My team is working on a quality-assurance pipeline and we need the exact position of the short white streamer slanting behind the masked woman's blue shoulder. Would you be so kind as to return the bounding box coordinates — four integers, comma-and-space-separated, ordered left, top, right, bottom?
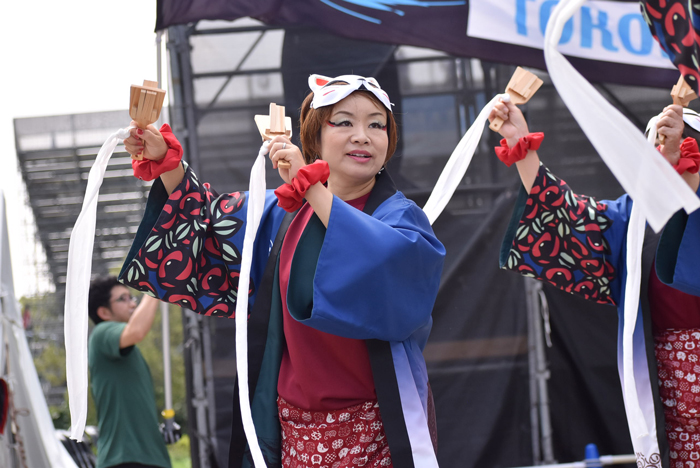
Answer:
423, 94, 510, 224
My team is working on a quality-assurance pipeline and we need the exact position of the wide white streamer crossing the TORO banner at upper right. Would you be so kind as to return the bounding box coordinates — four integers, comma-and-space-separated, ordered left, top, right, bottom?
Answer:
544, 0, 700, 232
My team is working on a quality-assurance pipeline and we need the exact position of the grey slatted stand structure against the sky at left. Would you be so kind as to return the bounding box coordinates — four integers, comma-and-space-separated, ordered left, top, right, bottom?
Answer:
15, 111, 150, 290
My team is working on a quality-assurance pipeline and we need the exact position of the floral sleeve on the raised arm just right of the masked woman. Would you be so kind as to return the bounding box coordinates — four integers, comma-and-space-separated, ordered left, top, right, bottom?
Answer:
500, 165, 631, 305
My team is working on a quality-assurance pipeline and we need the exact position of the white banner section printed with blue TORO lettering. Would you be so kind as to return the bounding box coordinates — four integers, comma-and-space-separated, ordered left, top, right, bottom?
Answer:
467, 0, 675, 69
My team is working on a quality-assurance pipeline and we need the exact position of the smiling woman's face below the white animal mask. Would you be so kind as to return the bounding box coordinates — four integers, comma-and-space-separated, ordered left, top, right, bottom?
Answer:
321, 93, 389, 186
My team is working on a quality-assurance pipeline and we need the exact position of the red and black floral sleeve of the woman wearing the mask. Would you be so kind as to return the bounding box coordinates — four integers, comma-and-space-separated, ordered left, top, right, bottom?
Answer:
119, 162, 284, 317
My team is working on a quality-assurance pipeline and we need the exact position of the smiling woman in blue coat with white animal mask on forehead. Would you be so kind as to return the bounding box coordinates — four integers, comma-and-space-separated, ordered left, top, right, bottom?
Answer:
115, 75, 445, 467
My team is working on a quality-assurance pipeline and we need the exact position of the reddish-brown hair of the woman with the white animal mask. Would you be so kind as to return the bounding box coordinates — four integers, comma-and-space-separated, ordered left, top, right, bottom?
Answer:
299, 89, 399, 164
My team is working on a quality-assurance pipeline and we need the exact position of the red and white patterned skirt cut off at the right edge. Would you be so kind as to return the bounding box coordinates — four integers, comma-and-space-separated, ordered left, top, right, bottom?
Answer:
654, 328, 700, 468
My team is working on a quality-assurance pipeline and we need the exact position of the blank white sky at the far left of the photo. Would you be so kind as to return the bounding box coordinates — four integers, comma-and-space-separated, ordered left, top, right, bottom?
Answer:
0, 0, 160, 297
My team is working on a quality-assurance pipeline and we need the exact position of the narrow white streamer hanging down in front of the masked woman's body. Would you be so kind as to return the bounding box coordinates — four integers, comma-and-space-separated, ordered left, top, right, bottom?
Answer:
236, 141, 270, 468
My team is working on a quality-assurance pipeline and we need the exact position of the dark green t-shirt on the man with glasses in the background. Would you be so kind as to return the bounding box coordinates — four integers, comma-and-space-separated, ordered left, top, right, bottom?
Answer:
88, 322, 170, 468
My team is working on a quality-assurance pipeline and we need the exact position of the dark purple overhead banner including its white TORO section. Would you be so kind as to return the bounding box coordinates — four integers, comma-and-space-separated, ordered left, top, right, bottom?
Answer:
156, 0, 678, 89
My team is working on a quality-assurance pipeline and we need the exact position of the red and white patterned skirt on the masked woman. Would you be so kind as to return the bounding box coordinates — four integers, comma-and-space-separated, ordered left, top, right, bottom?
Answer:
277, 397, 393, 468
